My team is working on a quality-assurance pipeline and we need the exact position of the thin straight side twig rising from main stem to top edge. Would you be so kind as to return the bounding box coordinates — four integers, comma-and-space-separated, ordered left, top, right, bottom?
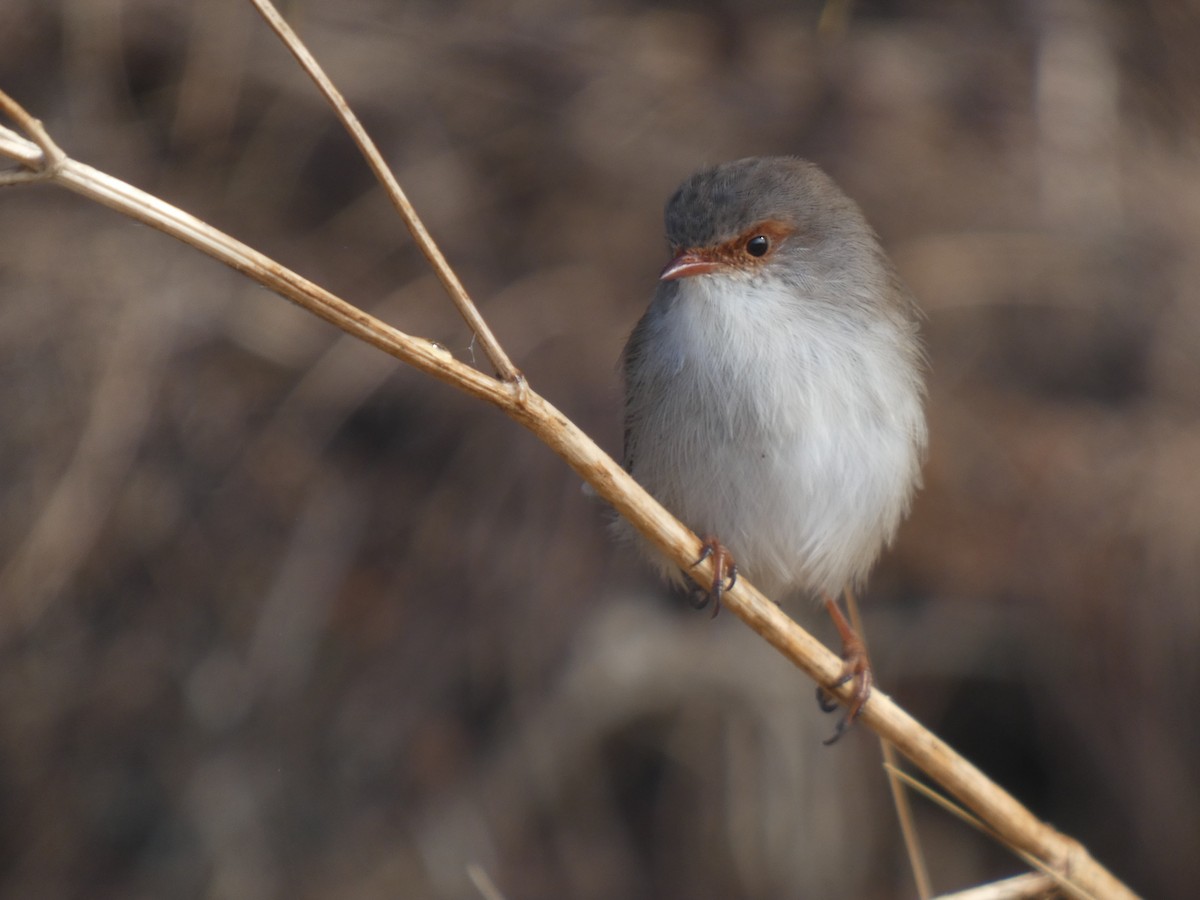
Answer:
250, 0, 524, 390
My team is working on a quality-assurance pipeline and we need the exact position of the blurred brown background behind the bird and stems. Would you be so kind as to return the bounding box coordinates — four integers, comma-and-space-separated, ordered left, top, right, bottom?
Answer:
0, 0, 1200, 900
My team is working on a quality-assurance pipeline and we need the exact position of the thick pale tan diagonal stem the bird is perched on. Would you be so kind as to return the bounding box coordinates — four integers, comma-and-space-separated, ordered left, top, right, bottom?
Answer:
0, 82, 1134, 899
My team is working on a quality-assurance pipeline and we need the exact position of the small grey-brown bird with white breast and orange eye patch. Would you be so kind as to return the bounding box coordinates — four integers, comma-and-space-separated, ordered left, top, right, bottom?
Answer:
620, 156, 928, 740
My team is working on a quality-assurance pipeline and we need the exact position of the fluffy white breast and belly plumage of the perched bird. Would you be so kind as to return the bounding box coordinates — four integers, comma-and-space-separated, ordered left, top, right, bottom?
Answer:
628, 277, 925, 599
